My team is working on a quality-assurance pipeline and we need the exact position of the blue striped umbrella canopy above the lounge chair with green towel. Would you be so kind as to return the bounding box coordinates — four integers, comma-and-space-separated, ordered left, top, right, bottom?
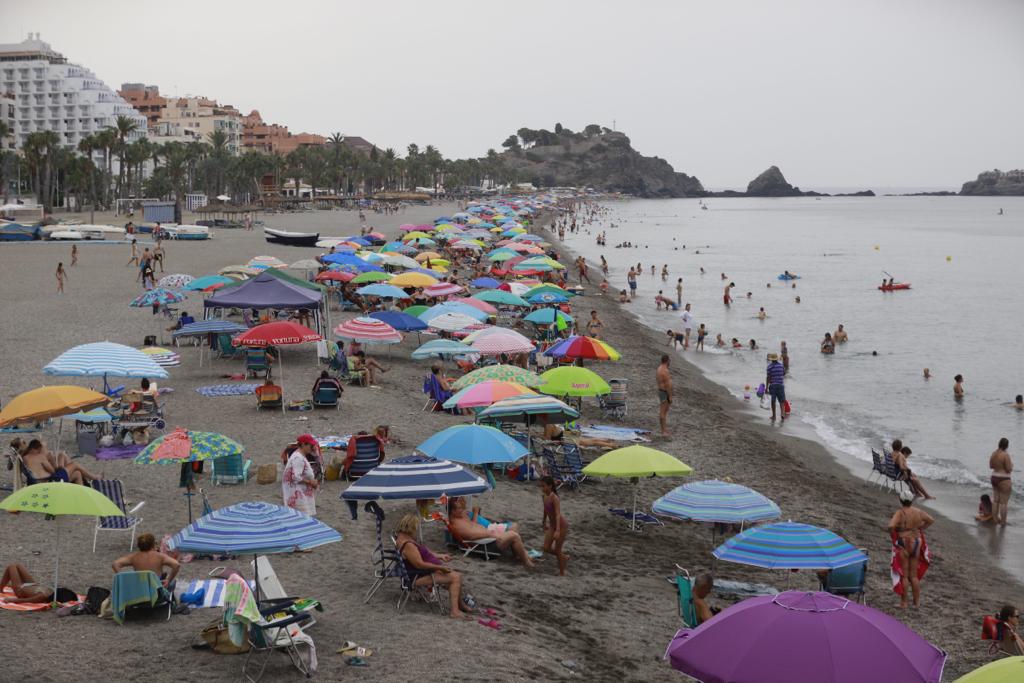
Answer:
169, 502, 341, 555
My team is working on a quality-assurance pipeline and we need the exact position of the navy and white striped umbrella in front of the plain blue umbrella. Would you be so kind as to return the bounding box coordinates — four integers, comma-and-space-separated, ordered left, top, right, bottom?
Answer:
341, 458, 489, 501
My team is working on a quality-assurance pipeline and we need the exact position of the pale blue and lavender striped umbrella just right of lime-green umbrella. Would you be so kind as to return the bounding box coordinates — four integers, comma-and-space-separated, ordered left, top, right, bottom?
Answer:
651, 479, 782, 524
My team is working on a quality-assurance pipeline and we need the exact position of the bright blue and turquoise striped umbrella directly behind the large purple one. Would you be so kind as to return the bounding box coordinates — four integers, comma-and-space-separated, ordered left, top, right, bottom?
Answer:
712, 522, 867, 569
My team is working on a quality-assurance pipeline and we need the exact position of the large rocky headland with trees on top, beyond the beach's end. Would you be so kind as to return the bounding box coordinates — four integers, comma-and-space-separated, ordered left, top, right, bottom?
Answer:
498, 124, 707, 198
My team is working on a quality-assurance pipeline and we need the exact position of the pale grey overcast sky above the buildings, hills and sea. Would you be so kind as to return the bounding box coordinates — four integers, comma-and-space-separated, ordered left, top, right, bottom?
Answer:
8, 0, 1024, 188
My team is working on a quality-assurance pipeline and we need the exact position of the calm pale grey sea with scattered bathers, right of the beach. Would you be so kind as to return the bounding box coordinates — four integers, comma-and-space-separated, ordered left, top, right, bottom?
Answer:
566, 197, 1024, 574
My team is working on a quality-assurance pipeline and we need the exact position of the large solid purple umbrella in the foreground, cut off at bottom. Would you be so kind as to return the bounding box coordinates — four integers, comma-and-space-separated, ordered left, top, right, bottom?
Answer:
666, 591, 946, 683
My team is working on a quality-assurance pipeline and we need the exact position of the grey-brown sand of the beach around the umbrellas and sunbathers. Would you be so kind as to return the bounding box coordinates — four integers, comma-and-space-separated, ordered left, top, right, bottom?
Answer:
0, 204, 1024, 681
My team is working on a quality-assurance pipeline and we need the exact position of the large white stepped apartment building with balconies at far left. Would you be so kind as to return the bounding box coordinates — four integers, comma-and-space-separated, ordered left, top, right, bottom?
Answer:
0, 33, 146, 147
